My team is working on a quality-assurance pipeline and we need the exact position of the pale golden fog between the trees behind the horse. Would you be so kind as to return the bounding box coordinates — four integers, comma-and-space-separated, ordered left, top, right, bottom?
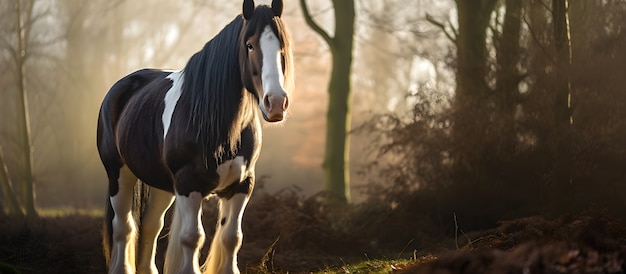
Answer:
0, 0, 446, 207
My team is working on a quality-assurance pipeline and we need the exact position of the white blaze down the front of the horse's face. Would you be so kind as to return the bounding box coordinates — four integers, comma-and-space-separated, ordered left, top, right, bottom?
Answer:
259, 26, 285, 105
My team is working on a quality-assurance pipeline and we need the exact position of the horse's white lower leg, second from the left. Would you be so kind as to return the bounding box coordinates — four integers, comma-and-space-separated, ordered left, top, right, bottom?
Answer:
137, 187, 174, 274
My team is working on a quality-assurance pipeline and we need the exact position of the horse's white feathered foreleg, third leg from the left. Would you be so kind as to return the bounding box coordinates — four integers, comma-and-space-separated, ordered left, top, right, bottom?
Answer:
164, 192, 204, 274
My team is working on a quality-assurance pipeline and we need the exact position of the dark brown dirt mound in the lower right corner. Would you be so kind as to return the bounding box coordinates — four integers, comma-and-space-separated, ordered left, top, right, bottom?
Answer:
396, 212, 626, 274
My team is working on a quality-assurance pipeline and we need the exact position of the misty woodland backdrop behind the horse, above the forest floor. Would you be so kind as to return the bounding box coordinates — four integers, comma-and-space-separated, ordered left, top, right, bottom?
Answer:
0, 0, 626, 228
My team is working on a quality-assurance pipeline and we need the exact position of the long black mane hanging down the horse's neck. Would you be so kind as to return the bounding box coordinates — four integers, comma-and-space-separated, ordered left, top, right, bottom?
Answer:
182, 16, 250, 161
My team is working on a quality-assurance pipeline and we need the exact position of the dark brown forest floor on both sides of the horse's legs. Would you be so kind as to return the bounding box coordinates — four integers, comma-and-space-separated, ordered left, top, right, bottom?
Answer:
0, 209, 626, 274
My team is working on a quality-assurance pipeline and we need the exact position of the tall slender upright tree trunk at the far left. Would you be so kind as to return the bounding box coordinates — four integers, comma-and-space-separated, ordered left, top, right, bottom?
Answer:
15, 0, 37, 217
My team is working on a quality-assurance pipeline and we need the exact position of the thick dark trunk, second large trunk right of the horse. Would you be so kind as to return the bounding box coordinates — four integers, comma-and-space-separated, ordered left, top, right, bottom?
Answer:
452, 0, 497, 163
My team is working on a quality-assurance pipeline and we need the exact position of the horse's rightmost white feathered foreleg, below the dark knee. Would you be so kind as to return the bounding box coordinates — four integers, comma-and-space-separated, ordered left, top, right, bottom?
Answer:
207, 193, 249, 274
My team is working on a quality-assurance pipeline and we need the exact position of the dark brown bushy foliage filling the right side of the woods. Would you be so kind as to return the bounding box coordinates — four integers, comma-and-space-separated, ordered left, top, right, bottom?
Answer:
354, 1, 626, 232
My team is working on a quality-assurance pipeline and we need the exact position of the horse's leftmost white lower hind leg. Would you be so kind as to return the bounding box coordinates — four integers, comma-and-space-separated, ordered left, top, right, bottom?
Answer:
109, 166, 137, 273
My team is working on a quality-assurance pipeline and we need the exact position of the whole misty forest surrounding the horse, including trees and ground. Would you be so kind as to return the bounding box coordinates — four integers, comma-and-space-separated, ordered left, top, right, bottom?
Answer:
0, 0, 626, 273
